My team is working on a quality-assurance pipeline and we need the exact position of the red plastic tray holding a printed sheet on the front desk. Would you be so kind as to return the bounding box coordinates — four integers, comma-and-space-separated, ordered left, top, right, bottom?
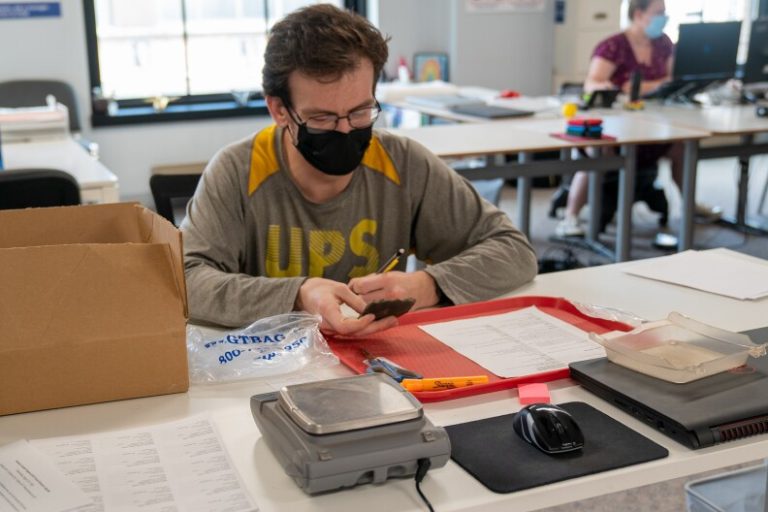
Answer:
328, 296, 632, 402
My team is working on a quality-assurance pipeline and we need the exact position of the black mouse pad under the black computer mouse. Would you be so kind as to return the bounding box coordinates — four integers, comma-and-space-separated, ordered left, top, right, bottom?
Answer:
445, 402, 669, 493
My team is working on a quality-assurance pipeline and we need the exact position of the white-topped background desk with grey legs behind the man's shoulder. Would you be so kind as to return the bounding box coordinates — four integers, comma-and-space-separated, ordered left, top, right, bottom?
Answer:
391, 114, 709, 261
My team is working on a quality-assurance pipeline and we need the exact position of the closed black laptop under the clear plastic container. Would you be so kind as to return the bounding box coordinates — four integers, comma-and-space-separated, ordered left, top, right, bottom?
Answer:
570, 328, 768, 449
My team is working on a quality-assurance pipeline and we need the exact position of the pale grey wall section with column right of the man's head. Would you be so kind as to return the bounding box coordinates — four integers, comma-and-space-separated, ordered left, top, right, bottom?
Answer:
378, 0, 554, 94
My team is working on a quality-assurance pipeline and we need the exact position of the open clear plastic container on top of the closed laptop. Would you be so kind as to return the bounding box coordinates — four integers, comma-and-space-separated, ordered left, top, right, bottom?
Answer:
589, 313, 767, 384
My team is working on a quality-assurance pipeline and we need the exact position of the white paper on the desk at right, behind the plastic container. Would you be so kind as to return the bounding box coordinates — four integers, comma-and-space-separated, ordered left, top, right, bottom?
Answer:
624, 249, 768, 300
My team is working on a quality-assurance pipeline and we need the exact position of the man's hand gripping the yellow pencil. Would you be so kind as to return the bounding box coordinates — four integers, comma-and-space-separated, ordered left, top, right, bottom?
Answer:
349, 270, 439, 309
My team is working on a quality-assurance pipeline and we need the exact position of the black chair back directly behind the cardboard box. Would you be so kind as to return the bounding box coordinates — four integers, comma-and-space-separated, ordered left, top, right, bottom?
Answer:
0, 169, 80, 210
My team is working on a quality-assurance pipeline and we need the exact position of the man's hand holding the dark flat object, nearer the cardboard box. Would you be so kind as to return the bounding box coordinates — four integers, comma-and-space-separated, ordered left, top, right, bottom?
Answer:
296, 277, 397, 336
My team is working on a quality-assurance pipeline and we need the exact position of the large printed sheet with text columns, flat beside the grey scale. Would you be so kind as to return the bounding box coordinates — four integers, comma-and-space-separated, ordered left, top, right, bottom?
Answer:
30, 415, 258, 512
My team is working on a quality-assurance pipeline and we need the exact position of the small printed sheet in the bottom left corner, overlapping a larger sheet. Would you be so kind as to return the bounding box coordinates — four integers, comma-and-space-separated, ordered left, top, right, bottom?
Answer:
0, 440, 91, 512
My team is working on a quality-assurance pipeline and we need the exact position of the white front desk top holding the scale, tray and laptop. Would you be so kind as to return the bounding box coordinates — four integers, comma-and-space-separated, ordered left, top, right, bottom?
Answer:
0, 250, 768, 512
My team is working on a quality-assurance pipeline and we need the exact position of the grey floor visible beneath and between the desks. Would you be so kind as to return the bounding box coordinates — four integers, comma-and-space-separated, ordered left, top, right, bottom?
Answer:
492, 156, 768, 512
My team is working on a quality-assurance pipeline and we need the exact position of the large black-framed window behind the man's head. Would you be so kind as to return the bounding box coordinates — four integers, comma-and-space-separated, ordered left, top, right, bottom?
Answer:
84, 0, 365, 126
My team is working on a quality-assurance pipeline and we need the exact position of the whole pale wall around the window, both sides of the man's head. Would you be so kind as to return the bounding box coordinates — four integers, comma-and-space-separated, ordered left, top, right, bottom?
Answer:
0, 0, 554, 206
